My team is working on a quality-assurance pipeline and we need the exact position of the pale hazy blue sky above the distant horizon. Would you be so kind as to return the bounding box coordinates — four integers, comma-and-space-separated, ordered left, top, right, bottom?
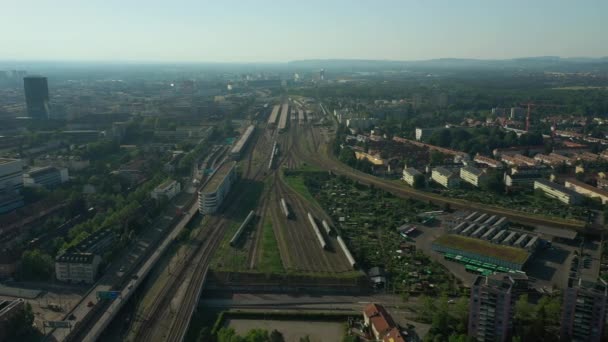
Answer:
0, 0, 608, 62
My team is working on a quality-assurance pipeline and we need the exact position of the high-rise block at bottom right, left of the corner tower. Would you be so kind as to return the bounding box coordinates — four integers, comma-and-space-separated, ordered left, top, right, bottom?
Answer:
469, 273, 527, 342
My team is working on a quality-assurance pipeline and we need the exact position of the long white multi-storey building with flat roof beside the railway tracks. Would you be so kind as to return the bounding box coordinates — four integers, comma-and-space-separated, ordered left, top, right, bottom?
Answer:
199, 162, 236, 215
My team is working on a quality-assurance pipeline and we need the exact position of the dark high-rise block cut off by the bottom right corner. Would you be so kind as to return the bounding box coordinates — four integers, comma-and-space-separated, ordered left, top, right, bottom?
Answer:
560, 278, 608, 342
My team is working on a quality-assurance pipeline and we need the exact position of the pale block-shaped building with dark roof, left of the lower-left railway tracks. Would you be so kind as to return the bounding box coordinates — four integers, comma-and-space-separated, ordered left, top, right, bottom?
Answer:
55, 251, 101, 284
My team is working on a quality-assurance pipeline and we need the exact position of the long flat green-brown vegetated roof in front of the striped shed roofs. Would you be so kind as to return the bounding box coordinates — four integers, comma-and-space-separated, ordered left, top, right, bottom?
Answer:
434, 234, 530, 264
